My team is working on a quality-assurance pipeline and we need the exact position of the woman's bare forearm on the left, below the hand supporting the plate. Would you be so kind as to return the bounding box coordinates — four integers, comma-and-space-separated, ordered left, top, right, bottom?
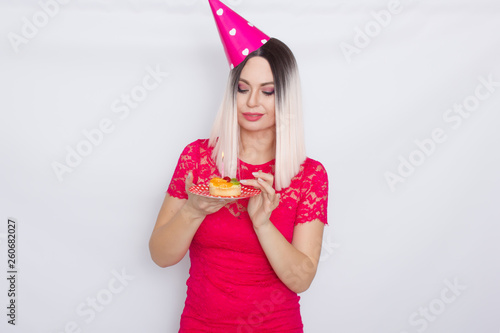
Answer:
149, 204, 204, 267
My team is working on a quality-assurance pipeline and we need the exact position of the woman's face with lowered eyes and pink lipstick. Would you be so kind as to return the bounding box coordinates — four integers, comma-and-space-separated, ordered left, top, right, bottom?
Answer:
236, 57, 275, 132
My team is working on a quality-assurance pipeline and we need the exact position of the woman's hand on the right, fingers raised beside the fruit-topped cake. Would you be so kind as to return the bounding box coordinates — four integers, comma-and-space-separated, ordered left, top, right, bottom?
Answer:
240, 171, 280, 228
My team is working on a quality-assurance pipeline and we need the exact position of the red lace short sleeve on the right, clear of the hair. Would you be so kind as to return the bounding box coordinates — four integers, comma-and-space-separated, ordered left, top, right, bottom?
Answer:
295, 160, 328, 224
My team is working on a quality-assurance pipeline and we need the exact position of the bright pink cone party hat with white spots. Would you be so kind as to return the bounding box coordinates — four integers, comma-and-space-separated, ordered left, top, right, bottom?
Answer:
208, 0, 269, 69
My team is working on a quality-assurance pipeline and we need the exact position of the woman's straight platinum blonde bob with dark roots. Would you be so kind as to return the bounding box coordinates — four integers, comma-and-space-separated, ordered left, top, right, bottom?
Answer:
209, 38, 306, 191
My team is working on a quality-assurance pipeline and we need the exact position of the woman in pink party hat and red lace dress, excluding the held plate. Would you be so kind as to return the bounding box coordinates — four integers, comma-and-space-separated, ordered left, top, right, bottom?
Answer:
149, 0, 328, 333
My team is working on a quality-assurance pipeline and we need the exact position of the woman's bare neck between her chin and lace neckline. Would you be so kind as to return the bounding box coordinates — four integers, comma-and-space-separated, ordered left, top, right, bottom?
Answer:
238, 128, 276, 164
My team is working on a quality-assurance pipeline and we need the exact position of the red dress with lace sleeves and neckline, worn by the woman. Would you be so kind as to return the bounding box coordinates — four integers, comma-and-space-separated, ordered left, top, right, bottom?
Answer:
167, 140, 328, 333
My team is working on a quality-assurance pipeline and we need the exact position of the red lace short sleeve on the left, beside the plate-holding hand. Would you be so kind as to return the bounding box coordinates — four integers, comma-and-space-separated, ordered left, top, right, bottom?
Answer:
167, 141, 200, 199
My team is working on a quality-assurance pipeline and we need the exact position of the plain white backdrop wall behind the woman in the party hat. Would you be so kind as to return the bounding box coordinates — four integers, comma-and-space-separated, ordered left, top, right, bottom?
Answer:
0, 0, 500, 333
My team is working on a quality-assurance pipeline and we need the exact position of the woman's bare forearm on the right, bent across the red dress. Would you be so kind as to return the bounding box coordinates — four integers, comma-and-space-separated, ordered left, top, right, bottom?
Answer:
254, 221, 317, 293
